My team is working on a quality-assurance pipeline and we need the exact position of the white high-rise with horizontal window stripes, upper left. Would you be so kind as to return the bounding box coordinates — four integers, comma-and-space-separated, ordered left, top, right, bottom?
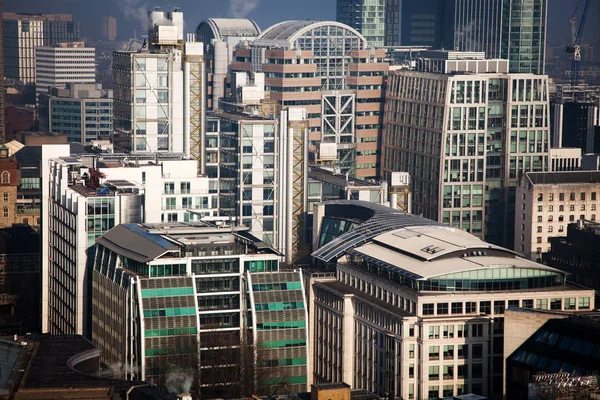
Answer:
35, 42, 96, 104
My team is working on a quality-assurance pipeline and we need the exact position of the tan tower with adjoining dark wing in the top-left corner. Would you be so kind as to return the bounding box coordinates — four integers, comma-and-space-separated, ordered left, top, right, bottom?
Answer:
3, 13, 79, 85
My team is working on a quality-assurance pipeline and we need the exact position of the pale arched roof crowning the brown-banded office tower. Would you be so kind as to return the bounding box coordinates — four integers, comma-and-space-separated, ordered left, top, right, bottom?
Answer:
254, 21, 367, 48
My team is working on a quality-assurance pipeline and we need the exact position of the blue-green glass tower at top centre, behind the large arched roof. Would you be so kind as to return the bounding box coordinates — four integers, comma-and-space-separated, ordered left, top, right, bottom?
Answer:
336, 0, 401, 47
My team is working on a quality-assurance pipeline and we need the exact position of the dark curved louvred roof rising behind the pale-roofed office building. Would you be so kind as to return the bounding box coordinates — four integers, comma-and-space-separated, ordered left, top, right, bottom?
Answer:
312, 200, 440, 263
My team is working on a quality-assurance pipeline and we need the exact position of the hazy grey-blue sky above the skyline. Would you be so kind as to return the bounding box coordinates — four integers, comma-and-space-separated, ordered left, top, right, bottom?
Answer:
4, 0, 600, 47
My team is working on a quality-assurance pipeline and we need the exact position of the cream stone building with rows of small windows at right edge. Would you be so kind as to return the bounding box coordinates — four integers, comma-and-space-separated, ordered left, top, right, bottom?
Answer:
514, 171, 600, 261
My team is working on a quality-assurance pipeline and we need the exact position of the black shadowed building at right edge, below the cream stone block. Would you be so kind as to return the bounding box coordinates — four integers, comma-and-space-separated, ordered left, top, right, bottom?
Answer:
542, 220, 600, 298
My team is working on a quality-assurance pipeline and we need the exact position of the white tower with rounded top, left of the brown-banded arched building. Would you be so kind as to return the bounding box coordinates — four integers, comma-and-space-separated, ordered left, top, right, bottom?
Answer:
196, 18, 260, 110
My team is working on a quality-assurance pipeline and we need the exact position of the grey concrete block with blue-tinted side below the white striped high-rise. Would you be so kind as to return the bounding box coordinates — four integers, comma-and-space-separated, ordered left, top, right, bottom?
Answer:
39, 83, 113, 145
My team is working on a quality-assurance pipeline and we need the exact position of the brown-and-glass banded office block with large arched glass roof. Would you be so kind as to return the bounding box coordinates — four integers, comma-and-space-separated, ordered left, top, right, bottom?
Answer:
232, 21, 389, 179
